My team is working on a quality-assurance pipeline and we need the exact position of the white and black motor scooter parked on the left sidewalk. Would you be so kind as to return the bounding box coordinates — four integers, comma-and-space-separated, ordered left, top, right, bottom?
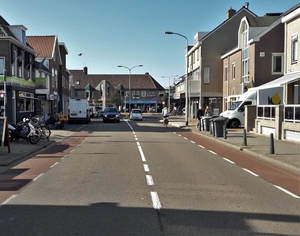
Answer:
8, 118, 40, 144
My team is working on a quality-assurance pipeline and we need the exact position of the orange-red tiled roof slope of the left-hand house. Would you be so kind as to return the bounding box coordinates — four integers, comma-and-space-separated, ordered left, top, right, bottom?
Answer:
26, 35, 57, 58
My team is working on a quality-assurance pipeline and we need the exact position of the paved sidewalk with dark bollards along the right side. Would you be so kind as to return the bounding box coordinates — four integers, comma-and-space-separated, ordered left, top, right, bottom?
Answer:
169, 116, 300, 174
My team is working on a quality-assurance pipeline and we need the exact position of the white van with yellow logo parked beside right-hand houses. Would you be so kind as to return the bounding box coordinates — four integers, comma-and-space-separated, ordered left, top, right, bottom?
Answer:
220, 86, 283, 128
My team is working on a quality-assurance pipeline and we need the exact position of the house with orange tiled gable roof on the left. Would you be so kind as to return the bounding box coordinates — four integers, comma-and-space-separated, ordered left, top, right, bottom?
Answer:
27, 35, 69, 114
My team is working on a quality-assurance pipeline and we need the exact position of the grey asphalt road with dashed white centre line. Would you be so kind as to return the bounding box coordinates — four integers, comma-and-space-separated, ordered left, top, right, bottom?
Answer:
0, 116, 300, 235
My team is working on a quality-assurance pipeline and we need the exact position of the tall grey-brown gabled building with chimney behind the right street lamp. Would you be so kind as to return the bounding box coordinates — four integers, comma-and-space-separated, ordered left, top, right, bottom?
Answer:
188, 5, 257, 117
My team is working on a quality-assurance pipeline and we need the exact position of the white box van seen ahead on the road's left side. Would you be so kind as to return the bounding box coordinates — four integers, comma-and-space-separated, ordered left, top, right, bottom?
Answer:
68, 98, 91, 124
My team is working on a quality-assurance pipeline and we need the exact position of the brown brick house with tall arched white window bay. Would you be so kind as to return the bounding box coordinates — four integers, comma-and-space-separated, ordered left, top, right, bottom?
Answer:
221, 14, 284, 110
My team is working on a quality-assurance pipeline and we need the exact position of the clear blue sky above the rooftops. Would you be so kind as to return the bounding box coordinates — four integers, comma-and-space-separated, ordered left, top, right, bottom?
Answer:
0, 0, 299, 86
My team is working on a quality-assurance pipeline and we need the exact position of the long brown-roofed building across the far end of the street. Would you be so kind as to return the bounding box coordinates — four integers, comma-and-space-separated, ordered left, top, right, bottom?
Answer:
69, 67, 165, 111
